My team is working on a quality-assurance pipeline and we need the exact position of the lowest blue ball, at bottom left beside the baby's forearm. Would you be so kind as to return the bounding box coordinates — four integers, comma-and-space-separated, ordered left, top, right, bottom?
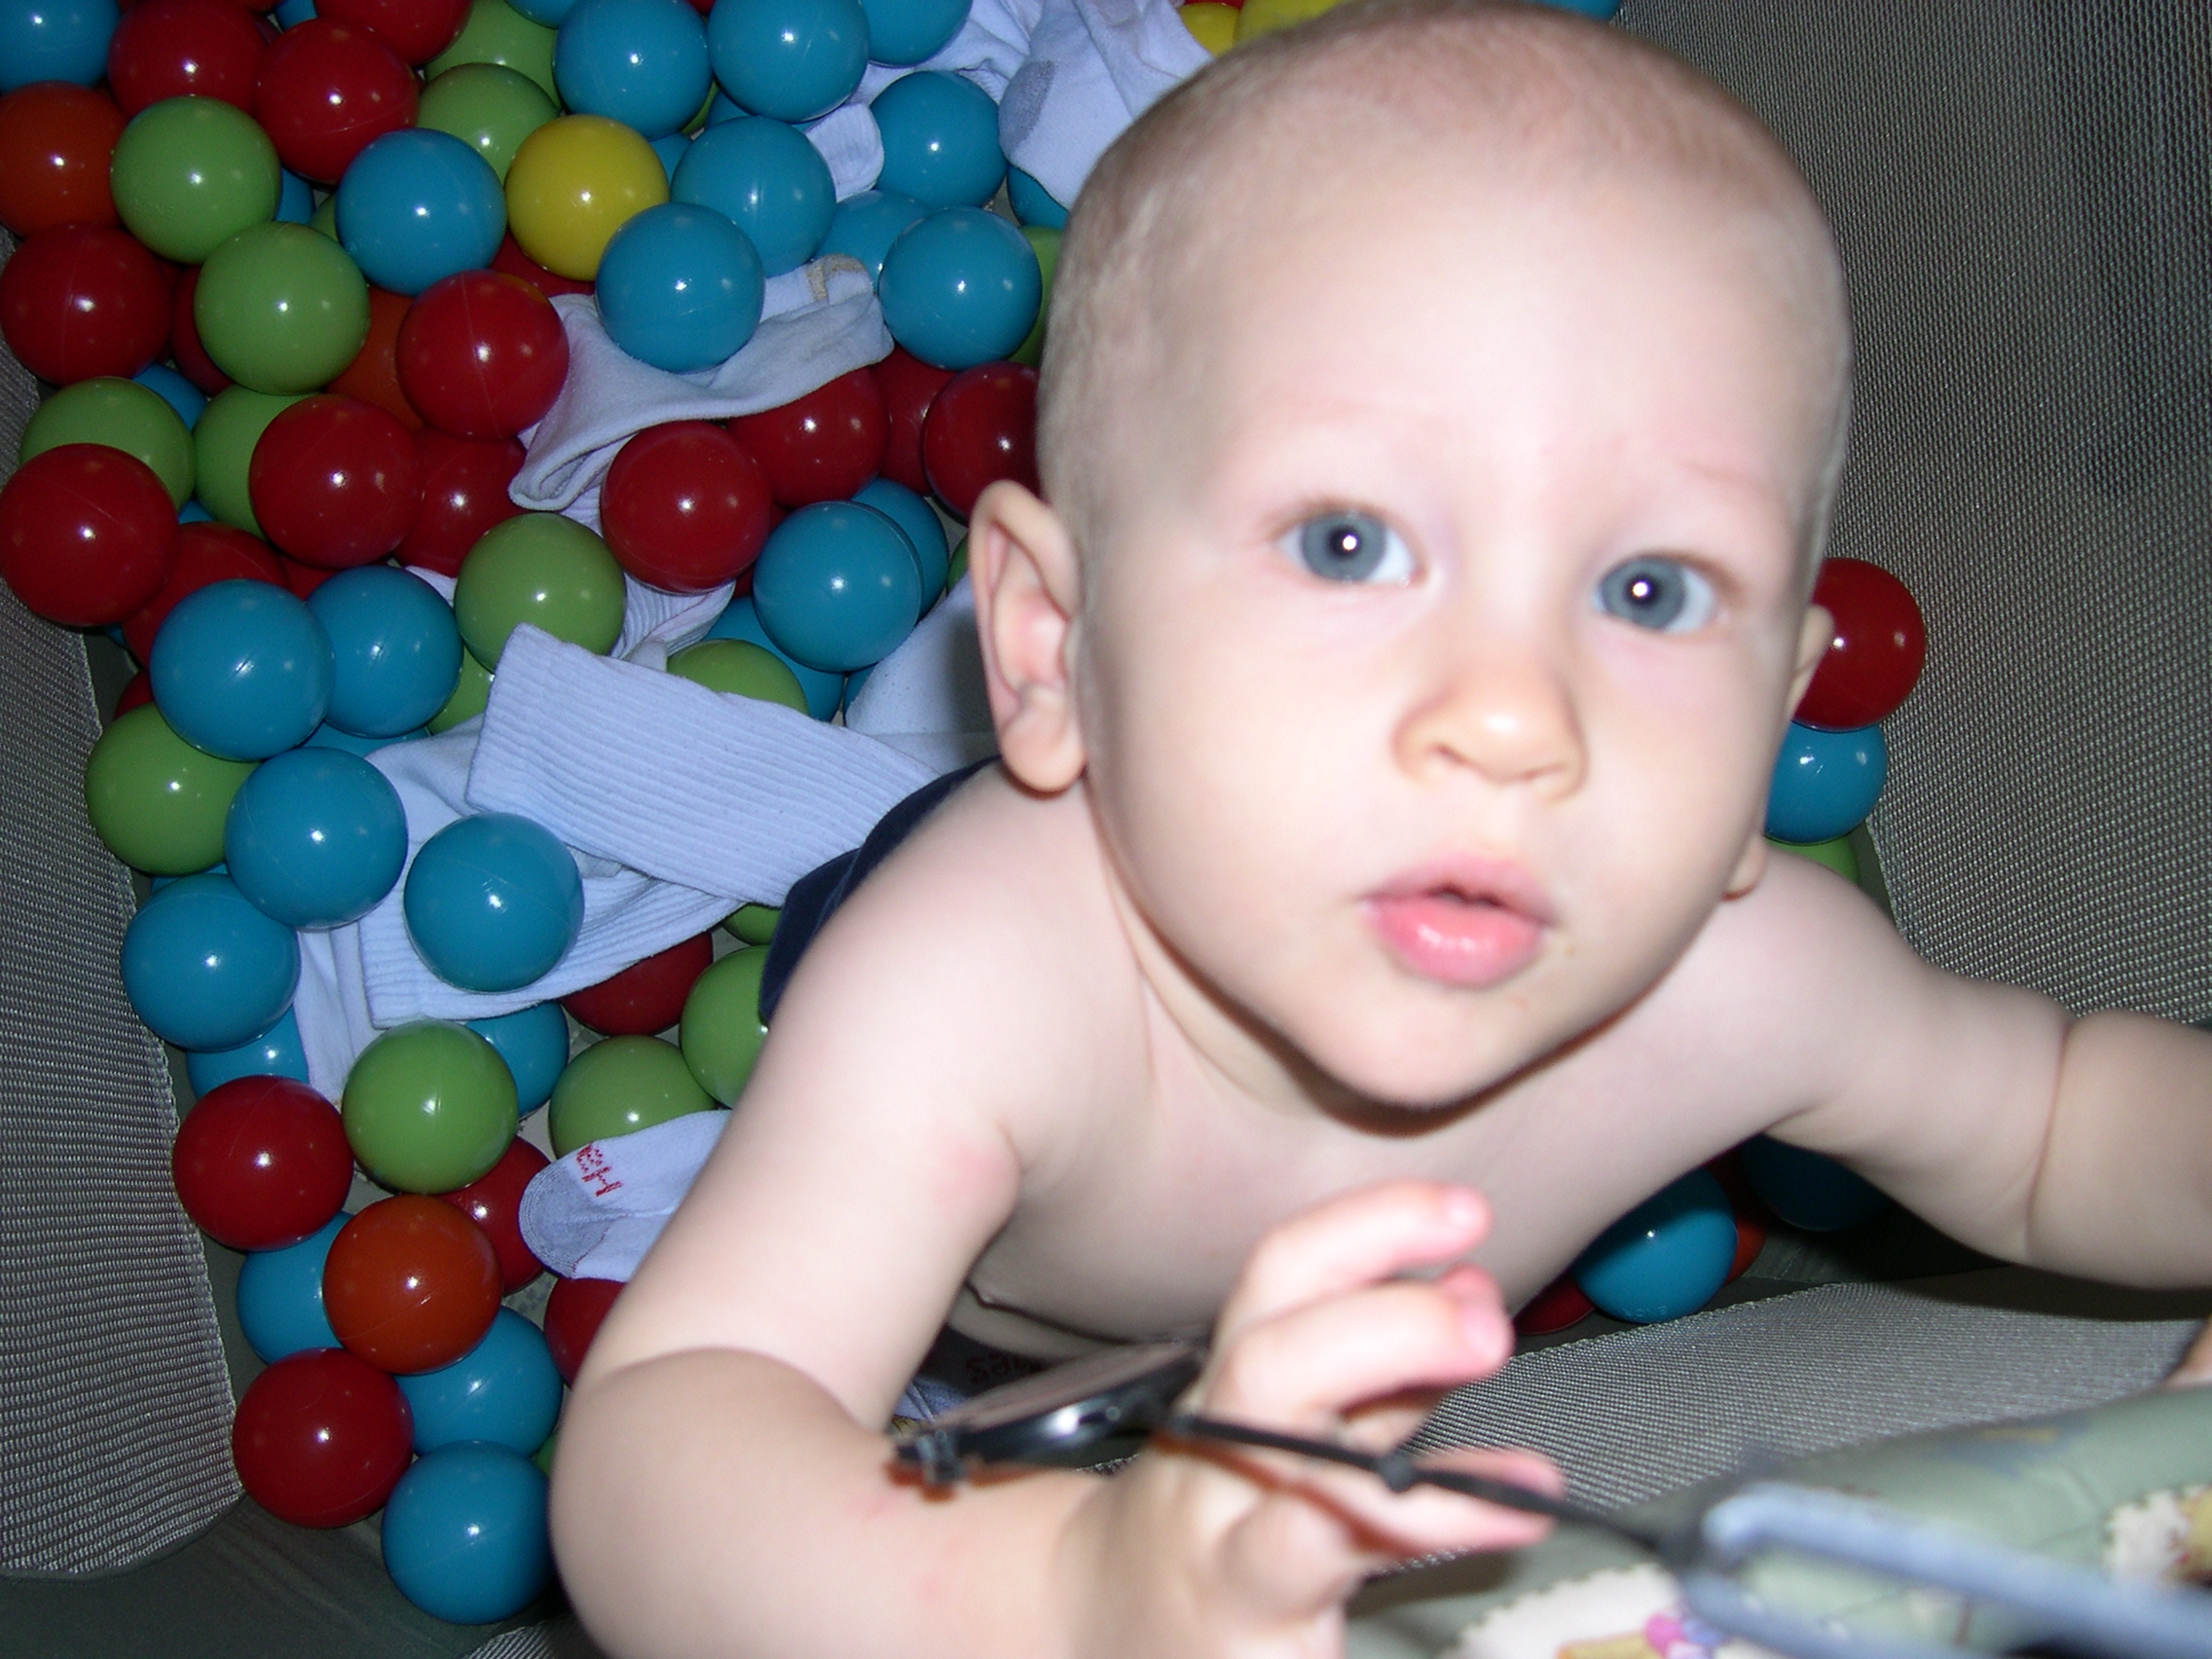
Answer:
383, 1442, 553, 1624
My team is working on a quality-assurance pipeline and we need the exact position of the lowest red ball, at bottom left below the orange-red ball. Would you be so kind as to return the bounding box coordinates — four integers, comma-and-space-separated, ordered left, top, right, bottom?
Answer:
230, 1347, 414, 1527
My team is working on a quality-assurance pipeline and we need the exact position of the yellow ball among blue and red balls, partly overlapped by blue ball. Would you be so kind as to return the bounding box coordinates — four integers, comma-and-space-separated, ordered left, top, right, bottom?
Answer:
506, 115, 668, 283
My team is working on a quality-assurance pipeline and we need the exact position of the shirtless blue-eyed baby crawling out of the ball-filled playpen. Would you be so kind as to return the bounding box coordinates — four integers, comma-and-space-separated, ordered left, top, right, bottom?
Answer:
539, 0, 2212, 1659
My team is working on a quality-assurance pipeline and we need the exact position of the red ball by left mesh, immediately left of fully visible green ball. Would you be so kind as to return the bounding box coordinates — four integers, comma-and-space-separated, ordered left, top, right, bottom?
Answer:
168, 1077, 354, 1250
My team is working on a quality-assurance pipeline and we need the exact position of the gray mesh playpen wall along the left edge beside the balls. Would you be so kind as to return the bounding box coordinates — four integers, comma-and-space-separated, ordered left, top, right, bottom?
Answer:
0, 239, 239, 1572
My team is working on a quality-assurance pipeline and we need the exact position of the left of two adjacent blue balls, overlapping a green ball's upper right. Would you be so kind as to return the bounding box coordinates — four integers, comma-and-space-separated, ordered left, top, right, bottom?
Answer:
148, 582, 332, 765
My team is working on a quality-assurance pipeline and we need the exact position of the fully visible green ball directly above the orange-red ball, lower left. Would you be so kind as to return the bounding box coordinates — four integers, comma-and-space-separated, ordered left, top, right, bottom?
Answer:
339, 1019, 515, 1193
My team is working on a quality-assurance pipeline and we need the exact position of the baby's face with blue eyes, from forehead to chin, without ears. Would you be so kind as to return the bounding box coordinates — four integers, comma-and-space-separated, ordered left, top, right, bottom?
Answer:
1075, 149, 1833, 1104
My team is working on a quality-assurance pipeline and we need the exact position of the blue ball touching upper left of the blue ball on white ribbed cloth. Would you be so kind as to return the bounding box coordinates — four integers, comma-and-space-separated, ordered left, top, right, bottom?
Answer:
223, 748, 407, 927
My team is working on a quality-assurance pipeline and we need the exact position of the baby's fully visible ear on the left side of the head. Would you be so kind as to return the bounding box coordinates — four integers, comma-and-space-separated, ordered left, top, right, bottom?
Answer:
969, 482, 1084, 794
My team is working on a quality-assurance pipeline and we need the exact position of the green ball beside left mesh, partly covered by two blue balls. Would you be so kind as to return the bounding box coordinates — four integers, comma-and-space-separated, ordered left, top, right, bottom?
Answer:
84, 703, 254, 876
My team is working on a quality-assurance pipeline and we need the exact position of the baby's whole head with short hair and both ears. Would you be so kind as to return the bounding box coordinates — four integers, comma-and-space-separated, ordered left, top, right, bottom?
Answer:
971, 0, 1847, 1119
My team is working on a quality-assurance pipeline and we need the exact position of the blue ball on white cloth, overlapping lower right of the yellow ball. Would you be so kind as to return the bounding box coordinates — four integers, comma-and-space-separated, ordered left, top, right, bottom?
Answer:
597, 202, 767, 374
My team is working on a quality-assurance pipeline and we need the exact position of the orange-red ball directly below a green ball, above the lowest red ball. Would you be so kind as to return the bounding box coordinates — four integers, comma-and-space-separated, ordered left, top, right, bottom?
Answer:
323, 1193, 499, 1372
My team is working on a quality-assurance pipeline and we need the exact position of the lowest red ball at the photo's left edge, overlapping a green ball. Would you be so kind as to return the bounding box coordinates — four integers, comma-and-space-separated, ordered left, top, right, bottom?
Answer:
0, 449, 177, 628
